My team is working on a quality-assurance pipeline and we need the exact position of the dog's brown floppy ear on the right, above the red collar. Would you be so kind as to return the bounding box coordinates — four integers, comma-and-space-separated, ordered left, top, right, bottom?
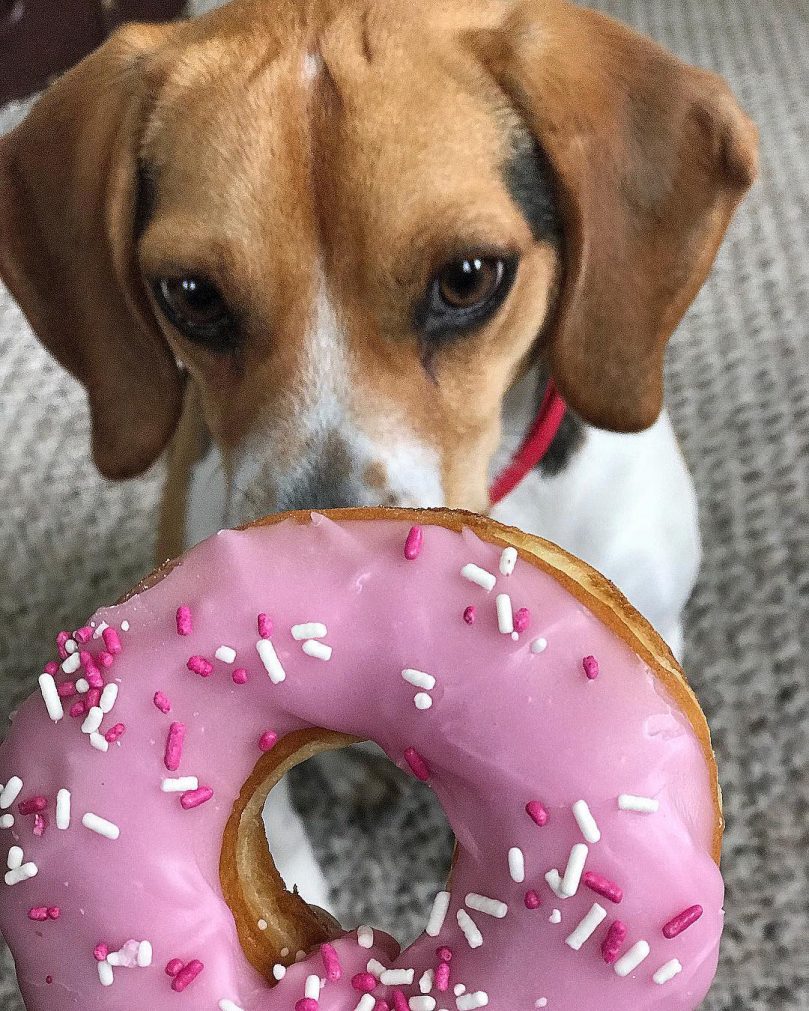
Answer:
475, 0, 757, 431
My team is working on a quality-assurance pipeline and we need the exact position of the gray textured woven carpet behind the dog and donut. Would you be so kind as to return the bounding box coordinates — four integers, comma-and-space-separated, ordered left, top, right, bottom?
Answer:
0, 0, 809, 1011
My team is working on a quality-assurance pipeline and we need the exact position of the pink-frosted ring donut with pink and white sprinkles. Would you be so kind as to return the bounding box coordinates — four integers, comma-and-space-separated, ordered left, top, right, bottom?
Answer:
0, 510, 723, 1011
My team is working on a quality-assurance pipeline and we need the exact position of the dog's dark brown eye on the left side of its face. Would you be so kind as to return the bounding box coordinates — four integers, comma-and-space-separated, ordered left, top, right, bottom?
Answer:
153, 277, 236, 351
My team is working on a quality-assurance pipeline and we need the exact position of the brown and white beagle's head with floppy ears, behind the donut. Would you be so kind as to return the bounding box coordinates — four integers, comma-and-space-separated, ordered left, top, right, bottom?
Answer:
0, 0, 755, 510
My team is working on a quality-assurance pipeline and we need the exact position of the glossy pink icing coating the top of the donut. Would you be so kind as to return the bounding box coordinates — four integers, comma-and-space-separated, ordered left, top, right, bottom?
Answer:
0, 516, 723, 1011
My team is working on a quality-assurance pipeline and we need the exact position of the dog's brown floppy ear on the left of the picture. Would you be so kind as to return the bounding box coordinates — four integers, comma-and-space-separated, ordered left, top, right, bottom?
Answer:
0, 26, 182, 477
